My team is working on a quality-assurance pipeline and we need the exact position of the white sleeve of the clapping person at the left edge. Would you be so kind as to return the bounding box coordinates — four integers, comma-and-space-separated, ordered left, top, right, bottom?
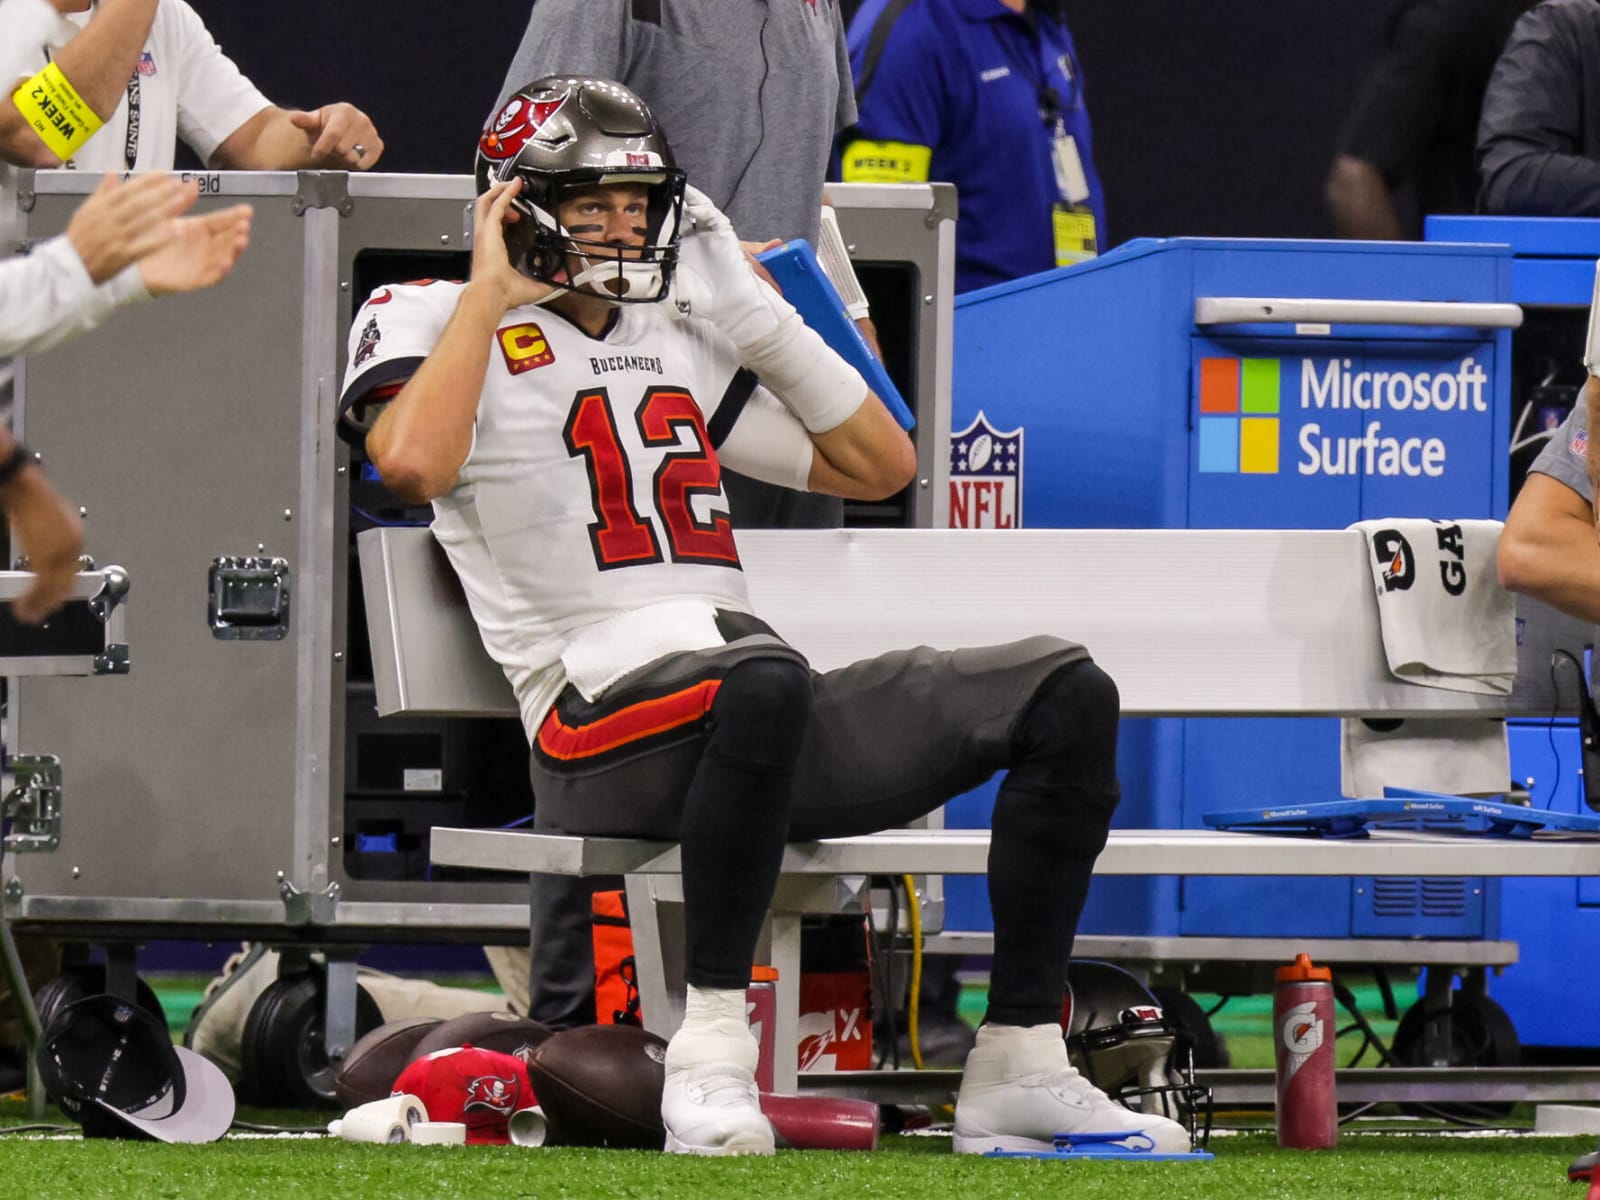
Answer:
0, 237, 150, 358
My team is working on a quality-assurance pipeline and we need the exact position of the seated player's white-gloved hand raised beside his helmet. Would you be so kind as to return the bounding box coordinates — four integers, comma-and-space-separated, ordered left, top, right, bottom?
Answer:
672, 187, 794, 347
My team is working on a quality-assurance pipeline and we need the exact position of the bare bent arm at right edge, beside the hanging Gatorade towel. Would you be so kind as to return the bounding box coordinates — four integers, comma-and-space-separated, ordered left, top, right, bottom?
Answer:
1498, 472, 1600, 624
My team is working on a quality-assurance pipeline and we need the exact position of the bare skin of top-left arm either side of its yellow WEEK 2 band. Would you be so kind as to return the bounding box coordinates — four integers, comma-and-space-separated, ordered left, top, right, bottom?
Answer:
0, 0, 158, 166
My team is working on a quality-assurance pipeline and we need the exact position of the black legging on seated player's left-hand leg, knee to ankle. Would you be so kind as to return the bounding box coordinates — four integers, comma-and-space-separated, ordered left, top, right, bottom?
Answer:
680, 658, 811, 989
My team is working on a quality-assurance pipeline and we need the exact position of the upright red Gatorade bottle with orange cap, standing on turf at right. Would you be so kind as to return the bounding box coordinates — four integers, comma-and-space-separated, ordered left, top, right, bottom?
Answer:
1272, 954, 1339, 1150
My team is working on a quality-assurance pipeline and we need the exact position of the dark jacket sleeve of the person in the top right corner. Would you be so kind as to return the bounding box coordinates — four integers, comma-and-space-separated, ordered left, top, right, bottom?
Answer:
1478, 6, 1600, 216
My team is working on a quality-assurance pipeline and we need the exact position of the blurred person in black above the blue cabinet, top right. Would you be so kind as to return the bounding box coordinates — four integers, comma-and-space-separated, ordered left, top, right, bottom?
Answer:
1323, 0, 1533, 242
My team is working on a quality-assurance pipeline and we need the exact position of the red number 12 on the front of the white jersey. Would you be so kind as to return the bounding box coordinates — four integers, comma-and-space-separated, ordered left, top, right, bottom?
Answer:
562, 387, 739, 571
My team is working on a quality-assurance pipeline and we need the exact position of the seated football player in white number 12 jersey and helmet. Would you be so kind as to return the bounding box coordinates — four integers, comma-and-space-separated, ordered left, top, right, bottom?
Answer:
341, 77, 1189, 1154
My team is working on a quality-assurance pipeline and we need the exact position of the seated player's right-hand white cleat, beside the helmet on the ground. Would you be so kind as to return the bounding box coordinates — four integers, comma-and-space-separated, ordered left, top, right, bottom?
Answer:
954, 1026, 1192, 1154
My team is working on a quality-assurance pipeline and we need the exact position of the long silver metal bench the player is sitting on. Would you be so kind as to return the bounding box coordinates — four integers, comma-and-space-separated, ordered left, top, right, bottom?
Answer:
358, 528, 1600, 1090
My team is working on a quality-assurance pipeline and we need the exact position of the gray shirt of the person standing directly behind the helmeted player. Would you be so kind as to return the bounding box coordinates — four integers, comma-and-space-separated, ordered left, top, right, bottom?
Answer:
494, 0, 856, 245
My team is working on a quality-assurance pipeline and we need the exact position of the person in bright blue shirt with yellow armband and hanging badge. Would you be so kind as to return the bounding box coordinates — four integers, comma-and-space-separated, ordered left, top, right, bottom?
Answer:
838, 0, 1106, 293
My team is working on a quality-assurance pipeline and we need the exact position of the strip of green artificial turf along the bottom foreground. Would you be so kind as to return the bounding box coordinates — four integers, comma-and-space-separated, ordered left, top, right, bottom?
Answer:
0, 1126, 1594, 1200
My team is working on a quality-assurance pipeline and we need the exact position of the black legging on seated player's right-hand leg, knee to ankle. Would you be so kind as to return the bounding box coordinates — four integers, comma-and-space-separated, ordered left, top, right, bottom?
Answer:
987, 661, 1120, 1026
